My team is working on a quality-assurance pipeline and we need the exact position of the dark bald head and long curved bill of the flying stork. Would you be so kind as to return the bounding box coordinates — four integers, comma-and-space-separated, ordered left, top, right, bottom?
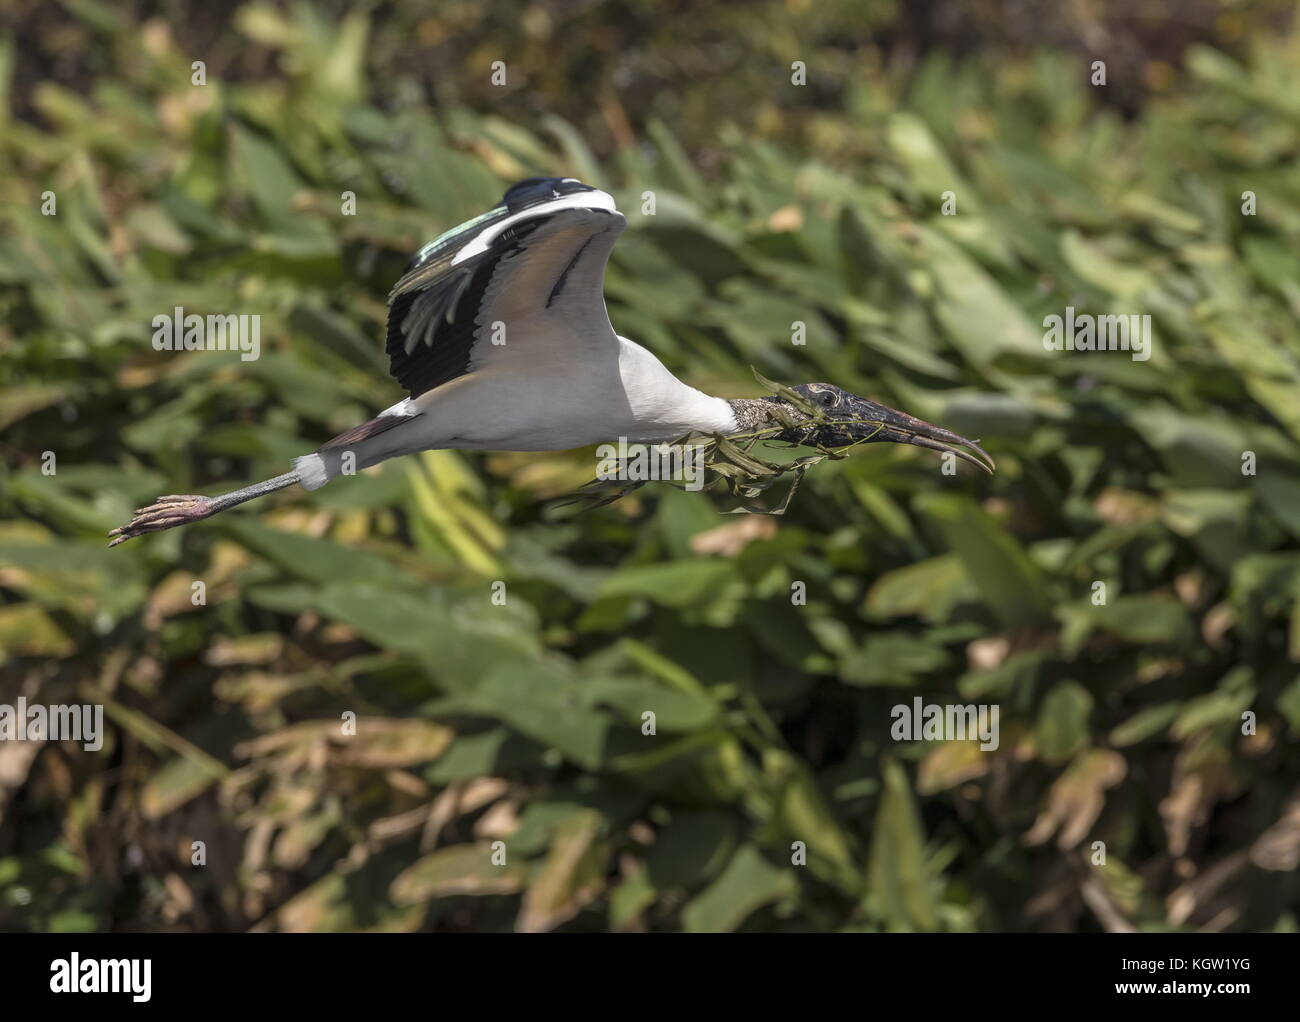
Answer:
768, 384, 995, 475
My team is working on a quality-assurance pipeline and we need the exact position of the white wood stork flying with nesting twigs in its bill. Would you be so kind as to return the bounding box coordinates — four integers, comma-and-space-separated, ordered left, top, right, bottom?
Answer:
109, 177, 993, 546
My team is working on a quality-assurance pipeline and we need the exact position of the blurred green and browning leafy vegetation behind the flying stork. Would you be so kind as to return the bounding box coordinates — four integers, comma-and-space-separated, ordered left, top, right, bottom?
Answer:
0, 0, 1300, 931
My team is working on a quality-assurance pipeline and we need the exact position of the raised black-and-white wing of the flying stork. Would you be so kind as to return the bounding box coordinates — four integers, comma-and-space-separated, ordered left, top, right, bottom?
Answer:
387, 178, 627, 397
